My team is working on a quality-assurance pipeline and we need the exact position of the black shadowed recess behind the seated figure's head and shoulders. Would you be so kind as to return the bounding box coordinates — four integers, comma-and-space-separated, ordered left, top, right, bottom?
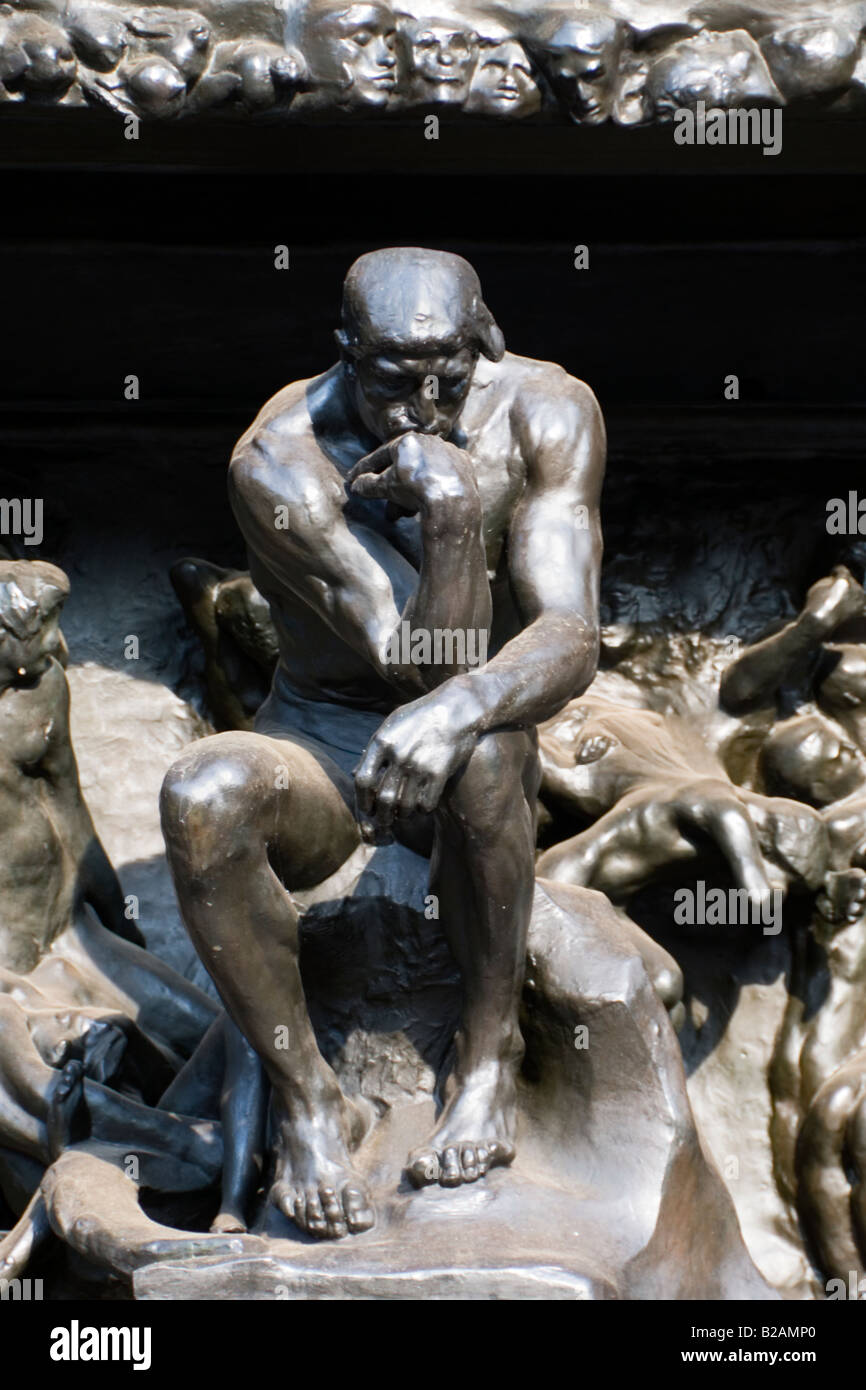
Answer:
0, 161, 866, 597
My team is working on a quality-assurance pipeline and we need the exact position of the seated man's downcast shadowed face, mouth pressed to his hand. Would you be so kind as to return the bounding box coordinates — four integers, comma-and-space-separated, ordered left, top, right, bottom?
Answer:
350, 345, 478, 439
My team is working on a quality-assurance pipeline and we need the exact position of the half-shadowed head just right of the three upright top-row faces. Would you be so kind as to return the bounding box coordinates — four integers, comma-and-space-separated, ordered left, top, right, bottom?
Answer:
544, 15, 619, 122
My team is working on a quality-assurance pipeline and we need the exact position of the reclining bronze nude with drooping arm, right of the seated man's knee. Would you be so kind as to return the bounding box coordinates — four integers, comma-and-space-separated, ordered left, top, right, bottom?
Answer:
538, 696, 827, 917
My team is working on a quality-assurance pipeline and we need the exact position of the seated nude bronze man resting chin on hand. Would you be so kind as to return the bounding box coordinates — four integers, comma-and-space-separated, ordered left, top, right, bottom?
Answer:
163, 249, 605, 1237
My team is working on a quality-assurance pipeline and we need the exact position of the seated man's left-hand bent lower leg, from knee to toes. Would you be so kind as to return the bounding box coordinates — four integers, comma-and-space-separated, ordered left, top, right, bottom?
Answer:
163, 734, 373, 1236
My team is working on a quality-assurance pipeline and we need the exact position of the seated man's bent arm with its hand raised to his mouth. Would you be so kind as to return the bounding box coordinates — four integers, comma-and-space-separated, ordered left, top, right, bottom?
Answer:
229, 430, 489, 699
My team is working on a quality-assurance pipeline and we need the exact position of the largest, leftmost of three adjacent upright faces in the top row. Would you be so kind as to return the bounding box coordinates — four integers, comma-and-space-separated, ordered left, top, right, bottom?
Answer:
310, 4, 396, 106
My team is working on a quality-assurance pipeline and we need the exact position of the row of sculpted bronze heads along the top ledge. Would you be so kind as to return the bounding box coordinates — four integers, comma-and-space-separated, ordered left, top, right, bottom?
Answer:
0, 0, 866, 125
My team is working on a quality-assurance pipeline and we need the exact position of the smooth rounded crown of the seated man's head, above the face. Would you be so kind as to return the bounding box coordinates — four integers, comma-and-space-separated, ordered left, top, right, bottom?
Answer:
339, 246, 505, 361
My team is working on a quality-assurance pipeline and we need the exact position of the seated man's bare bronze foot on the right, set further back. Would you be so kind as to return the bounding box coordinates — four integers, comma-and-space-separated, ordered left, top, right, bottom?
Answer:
406, 1063, 517, 1187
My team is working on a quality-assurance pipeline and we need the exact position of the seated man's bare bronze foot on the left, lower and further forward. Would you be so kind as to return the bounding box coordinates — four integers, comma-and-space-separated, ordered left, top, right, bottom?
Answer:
270, 1098, 375, 1240
